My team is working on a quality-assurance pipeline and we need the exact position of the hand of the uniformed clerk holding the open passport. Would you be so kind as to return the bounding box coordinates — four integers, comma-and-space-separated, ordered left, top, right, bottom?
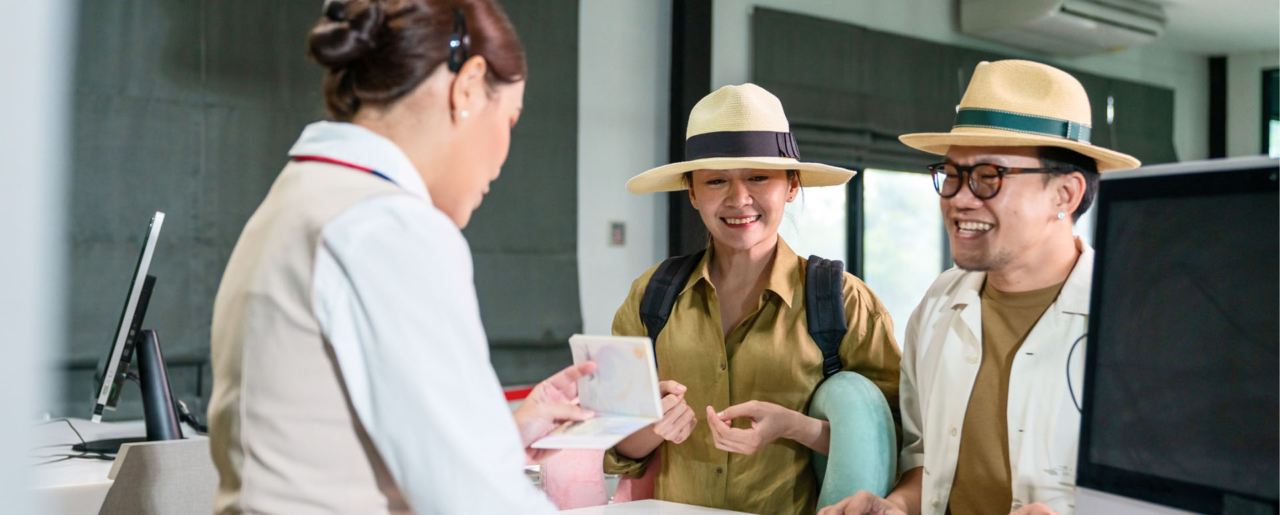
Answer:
512, 361, 595, 462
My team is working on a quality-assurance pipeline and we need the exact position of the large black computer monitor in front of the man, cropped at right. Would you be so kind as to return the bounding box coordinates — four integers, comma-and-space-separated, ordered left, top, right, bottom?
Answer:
1076, 158, 1280, 514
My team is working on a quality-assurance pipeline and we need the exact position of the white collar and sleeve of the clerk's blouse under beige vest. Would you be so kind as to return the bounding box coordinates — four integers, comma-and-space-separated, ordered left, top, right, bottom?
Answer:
289, 122, 554, 514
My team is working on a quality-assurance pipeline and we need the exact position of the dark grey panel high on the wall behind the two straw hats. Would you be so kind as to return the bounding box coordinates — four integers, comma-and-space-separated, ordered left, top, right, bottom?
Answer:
751, 8, 1178, 172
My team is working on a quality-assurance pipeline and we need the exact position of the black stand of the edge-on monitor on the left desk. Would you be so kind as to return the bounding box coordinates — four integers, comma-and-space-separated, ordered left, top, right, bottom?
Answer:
72, 329, 182, 455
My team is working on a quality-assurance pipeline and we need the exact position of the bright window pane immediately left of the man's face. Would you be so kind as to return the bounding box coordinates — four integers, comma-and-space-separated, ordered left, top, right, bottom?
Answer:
861, 169, 951, 346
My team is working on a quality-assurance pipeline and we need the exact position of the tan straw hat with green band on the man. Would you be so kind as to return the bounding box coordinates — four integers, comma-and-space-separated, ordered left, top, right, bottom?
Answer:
899, 60, 1142, 172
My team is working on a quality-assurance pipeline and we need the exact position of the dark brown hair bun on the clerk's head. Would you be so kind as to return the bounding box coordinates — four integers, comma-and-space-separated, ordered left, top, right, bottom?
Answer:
307, 0, 383, 69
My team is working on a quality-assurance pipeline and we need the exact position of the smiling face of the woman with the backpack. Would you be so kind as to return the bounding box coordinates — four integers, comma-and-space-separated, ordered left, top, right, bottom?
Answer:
689, 168, 800, 250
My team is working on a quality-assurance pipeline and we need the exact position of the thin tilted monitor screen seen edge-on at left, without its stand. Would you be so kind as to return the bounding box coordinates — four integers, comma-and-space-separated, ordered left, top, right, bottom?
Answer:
93, 211, 164, 423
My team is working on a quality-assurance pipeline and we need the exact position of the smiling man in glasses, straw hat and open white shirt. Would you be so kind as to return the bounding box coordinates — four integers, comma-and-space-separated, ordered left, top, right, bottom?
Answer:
820, 60, 1140, 515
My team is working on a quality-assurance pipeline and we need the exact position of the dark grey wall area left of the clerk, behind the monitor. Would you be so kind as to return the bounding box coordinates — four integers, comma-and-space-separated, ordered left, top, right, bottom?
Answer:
55, 0, 324, 418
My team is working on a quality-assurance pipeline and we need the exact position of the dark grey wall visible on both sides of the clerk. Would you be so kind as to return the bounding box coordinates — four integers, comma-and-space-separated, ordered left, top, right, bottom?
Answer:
58, 0, 581, 419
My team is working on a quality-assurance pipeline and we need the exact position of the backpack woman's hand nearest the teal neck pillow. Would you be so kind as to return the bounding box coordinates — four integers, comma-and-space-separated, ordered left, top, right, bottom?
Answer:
707, 401, 820, 455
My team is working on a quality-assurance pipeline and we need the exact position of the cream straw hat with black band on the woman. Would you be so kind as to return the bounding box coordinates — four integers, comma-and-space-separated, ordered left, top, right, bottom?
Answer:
627, 83, 856, 193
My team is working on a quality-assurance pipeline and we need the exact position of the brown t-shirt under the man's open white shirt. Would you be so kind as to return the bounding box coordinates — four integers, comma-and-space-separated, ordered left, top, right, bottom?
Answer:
947, 283, 1064, 515
